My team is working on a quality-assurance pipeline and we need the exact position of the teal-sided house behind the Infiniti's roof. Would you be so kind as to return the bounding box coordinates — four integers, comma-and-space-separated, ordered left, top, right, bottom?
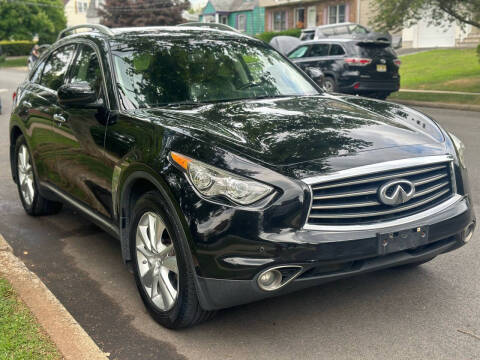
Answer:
200, 0, 265, 35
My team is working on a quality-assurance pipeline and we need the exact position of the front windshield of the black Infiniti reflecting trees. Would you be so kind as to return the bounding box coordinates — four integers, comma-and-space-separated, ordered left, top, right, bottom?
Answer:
113, 37, 318, 108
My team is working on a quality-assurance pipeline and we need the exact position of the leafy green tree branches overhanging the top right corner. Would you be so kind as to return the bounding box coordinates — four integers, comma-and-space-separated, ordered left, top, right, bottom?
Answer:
371, 0, 480, 31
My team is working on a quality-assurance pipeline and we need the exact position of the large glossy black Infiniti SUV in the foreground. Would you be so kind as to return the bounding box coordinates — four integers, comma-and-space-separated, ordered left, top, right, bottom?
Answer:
10, 25, 475, 328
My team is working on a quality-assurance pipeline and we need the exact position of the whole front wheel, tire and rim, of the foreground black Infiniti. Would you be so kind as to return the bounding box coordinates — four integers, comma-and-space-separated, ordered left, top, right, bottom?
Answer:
129, 191, 213, 329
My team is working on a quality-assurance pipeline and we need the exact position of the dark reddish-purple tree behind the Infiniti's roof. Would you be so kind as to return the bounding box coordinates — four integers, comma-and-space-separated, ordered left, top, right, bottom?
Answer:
100, 0, 190, 27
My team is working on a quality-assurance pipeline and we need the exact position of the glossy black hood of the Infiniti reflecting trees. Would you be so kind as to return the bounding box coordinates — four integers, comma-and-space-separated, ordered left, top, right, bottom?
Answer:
141, 95, 444, 167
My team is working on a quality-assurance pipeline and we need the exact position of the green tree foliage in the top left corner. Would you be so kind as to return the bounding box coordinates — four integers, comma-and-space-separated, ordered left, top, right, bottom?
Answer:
0, 0, 66, 43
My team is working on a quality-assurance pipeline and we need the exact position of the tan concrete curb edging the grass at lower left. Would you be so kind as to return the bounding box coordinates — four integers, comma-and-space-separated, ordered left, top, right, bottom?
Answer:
0, 235, 108, 360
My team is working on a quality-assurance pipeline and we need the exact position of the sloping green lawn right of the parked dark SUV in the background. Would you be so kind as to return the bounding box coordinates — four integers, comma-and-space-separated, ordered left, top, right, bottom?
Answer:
400, 49, 480, 93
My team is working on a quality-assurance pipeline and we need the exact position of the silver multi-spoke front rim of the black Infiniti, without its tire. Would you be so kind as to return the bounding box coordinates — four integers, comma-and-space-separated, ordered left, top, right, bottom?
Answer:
135, 212, 178, 311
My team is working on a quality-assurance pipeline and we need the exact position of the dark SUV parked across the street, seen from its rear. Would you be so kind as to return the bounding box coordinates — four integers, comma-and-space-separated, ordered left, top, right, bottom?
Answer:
288, 39, 401, 100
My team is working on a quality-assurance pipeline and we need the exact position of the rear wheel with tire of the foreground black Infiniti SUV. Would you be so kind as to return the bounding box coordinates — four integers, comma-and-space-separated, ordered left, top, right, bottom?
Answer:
13, 135, 63, 216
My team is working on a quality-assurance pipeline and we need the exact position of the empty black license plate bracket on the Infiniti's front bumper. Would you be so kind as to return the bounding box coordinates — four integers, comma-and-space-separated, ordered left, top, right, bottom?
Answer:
377, 226, 429, 255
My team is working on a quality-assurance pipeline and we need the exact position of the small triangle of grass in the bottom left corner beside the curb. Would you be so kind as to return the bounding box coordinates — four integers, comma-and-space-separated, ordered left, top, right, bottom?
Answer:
0, 278, 61, 360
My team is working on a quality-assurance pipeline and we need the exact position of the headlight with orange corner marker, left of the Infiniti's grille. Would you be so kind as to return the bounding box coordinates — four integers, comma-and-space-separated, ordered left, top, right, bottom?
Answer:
170, 151, 273, 205
